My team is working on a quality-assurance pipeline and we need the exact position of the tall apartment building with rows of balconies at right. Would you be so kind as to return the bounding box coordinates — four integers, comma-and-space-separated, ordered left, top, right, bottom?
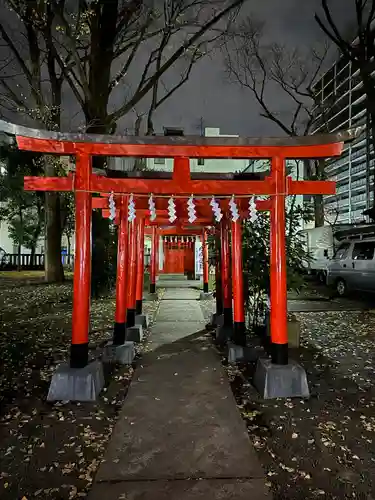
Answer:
312, 55, 374, 223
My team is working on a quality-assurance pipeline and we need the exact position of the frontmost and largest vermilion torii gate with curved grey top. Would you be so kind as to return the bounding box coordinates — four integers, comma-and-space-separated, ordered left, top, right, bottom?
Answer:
3, 125, 356, 402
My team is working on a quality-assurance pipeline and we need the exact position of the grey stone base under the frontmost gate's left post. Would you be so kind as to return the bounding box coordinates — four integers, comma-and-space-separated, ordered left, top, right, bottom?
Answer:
47, 361, 104, 402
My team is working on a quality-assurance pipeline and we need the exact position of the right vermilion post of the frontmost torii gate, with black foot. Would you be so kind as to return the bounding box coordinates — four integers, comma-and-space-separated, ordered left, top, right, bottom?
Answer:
270, 156, 288, 365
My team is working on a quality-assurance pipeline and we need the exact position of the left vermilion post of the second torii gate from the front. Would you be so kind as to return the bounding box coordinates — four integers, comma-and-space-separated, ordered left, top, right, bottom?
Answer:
113, 196, 128, 345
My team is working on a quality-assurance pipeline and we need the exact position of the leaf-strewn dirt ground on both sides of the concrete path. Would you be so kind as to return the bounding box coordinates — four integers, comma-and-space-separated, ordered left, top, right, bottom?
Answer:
0, 276, 375, 500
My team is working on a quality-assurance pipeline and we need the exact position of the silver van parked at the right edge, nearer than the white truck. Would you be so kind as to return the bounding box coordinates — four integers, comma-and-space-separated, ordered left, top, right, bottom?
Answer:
327, 234, 375, 296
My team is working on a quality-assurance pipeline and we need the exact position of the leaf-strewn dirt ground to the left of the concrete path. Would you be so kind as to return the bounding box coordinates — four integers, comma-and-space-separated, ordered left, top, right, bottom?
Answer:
0, 276, 157, 500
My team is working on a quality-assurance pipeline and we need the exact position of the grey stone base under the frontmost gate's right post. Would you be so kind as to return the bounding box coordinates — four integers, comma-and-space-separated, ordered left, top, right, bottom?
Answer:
254, 358, 310, 399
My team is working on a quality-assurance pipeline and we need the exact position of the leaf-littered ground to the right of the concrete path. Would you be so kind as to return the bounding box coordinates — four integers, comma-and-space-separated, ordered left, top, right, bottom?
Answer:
202, 296, 375, 500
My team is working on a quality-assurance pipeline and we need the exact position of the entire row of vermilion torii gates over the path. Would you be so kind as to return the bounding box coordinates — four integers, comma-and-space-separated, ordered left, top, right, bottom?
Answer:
0, 122, 358, 399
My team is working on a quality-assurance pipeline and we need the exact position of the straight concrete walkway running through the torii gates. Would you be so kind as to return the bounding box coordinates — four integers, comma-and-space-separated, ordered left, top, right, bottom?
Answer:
89, 289, 271, 500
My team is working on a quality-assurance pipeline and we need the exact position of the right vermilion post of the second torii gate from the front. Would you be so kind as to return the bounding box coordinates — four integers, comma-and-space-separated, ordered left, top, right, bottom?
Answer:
232, 220, 246, 346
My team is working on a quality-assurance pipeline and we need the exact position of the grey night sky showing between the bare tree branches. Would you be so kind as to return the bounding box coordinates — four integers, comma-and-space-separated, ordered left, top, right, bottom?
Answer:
0, 0, 355, 136
